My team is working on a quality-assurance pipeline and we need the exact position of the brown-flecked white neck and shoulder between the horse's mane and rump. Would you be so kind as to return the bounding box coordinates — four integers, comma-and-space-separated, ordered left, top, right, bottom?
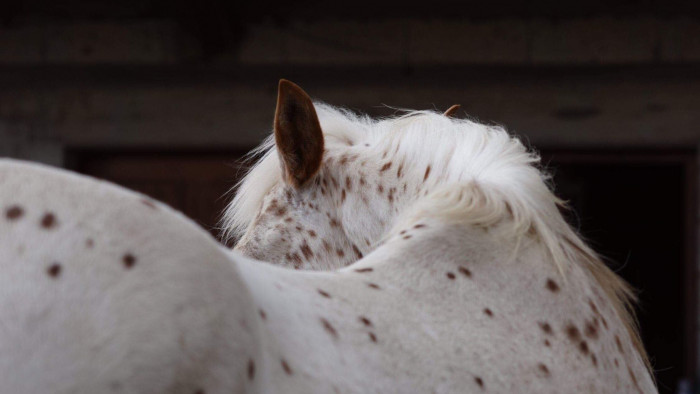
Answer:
235, 220, 654, 392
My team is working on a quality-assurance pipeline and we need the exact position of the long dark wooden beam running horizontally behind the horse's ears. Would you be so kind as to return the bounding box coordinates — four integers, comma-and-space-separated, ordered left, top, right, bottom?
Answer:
0, 67, 700, 149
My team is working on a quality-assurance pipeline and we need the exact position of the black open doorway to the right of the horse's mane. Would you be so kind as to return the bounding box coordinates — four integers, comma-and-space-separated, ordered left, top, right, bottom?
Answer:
543, 152, 696, 393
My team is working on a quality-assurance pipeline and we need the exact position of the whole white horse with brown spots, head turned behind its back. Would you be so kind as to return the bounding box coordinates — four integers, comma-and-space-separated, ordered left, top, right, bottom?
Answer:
0, 81, 656, 394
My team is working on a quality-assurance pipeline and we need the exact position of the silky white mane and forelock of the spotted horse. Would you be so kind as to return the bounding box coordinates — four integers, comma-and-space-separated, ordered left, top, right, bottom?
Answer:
222, 103, 651, 370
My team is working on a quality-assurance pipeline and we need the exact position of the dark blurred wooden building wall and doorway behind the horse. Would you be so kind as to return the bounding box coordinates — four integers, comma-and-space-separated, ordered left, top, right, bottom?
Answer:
0, 0, 700, 393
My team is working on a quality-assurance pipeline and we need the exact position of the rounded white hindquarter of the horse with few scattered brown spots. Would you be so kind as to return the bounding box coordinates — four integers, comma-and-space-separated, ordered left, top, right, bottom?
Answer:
0, 160, 253, 393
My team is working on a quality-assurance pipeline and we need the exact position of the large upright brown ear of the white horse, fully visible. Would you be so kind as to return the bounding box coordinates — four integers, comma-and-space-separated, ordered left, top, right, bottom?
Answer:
274, 79, 323, 187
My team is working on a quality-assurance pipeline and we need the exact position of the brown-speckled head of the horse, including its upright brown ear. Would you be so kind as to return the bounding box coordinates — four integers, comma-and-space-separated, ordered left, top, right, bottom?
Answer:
225, 80, 396, 269
